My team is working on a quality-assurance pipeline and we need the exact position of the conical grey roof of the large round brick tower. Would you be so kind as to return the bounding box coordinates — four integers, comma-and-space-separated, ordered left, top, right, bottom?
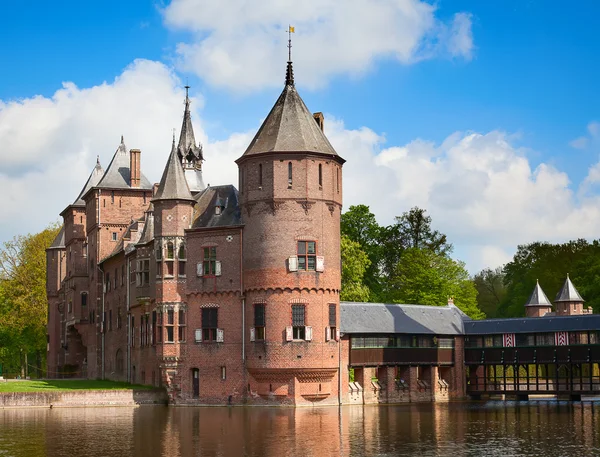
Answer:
238, 62, 343, 161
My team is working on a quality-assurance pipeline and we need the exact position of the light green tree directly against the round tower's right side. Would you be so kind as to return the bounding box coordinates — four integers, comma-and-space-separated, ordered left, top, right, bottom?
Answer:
340, 235, 371, 302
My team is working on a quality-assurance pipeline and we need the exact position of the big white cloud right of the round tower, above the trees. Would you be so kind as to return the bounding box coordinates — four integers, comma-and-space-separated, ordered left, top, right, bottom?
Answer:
326, 120, 600, 272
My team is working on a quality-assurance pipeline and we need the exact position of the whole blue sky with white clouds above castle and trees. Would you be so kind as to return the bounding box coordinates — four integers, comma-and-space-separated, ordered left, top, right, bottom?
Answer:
0, 0, 600, 273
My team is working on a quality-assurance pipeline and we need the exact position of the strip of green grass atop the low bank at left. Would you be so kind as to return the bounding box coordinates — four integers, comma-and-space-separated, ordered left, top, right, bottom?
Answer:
0, 379, 154, 393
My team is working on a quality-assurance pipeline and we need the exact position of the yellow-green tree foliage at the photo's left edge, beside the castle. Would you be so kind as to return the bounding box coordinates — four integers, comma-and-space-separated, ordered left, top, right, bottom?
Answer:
0, 225, 59, 371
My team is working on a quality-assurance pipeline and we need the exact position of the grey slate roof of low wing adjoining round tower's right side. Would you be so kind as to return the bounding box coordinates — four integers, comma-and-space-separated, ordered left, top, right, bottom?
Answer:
340, 302, 471, 335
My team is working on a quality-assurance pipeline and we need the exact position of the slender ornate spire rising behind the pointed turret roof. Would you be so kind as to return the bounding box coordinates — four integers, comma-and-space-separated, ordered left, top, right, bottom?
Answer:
177, 86, 204, 193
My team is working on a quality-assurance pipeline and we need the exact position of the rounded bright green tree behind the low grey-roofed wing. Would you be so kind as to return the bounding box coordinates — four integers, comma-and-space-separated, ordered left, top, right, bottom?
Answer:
391, 248, 485, 319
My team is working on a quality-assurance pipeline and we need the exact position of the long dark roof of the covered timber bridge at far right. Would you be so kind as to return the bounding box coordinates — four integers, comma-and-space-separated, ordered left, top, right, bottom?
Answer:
465, 314, 600, 335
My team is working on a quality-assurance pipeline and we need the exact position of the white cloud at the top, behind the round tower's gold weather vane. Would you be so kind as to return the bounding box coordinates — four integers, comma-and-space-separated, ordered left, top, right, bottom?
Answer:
163, 0, 473, 92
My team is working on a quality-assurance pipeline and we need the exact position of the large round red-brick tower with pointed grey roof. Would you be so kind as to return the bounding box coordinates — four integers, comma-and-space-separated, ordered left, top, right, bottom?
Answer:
236, 61, 344, 404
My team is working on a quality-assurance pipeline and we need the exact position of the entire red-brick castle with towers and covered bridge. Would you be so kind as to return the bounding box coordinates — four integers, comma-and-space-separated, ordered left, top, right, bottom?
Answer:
47, 56, 600, 405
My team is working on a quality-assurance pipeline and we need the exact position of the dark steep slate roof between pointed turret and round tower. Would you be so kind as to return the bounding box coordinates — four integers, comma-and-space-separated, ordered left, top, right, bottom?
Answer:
192, 185, 242, 228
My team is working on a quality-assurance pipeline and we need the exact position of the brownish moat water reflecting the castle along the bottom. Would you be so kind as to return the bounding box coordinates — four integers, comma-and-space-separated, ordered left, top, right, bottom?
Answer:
0, 401, 600, 457
